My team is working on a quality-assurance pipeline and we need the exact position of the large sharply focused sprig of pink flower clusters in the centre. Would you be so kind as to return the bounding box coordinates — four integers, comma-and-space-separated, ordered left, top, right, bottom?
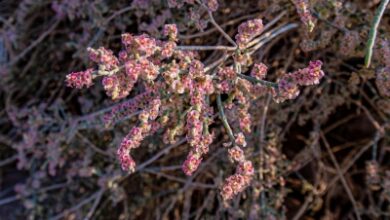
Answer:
67, 1, 324, 200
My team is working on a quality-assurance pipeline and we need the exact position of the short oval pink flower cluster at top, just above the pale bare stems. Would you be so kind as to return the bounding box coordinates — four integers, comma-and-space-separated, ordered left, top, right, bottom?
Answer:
236, 19, 264, 49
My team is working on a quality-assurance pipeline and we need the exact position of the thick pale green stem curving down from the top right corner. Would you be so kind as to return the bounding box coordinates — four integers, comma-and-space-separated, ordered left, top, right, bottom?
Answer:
364, 0, 389, 68
